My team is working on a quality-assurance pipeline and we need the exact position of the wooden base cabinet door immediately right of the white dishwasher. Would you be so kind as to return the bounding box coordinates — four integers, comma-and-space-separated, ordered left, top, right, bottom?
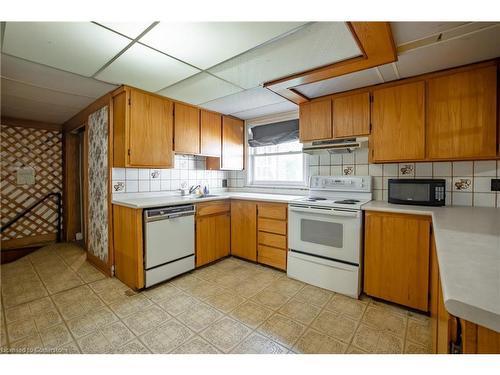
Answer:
196, 212, 230, 267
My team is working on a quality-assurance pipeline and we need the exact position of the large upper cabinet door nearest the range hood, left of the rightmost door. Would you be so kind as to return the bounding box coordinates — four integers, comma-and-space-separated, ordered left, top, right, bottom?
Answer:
371, 82, 425, 161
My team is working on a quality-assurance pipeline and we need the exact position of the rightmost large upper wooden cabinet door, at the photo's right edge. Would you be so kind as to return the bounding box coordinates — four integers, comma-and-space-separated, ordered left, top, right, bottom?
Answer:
427, 66, 497, 159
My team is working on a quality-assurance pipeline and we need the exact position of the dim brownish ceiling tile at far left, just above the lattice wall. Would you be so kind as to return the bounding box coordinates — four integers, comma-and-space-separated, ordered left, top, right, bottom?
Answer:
1, 94, 79, 124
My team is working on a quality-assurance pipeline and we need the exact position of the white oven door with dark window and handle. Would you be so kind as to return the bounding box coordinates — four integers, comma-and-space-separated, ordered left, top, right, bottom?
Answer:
288, 205, 362, 265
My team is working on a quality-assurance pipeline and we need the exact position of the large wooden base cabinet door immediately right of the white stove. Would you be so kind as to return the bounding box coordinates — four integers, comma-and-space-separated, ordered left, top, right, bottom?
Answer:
364, 212, 430, 311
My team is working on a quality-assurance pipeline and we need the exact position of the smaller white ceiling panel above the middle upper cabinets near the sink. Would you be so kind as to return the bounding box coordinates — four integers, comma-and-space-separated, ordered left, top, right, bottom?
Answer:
158, 72, 242, 105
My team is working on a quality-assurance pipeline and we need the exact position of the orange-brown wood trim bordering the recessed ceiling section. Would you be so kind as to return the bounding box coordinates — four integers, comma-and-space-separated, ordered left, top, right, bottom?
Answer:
264, 22, 397, 104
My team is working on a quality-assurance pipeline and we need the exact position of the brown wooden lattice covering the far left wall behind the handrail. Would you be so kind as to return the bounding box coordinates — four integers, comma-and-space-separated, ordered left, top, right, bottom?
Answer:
0, 125, 62, 242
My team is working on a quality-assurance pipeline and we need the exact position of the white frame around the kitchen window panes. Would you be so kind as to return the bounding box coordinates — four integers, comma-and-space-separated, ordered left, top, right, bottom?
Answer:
245, 116, 309, 189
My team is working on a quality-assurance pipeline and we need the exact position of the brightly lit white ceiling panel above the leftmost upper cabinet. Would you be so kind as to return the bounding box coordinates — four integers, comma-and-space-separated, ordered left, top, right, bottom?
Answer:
96, 44, 199, 91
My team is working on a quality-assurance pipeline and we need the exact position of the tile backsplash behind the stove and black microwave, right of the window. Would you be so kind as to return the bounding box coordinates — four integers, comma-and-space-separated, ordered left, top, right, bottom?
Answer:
308, 149, 500, 207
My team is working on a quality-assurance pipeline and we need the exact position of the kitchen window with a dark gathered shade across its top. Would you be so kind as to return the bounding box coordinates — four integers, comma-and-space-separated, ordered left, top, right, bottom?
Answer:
247, 120, 307, 187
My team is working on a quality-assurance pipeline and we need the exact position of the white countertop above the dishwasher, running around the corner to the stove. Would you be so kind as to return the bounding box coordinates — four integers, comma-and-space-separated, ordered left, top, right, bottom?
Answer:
112, 192, 303, 208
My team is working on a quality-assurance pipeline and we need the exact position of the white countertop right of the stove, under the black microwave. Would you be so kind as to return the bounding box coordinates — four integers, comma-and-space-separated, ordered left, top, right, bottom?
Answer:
362, 201, 500, 332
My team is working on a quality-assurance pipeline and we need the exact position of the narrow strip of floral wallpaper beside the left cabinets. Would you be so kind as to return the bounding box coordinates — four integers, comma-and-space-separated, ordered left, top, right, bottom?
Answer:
87, 106, 109, 263
